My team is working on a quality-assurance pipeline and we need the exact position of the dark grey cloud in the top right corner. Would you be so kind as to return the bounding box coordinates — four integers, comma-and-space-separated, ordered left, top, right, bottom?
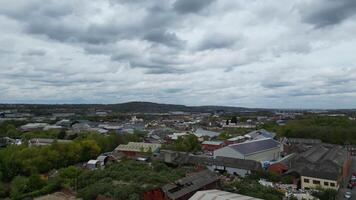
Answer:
301, 0, 356, 27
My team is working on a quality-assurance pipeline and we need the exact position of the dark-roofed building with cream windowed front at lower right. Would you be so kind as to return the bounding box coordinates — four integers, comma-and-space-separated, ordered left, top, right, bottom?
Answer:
286, 144, 351, 190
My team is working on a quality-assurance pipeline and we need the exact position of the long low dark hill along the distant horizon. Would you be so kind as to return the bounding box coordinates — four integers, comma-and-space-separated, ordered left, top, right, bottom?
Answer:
0, 102, 253, 113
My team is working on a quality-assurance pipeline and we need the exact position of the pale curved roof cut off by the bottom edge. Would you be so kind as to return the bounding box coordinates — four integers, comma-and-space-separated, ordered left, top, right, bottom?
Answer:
189, 190, 262, 200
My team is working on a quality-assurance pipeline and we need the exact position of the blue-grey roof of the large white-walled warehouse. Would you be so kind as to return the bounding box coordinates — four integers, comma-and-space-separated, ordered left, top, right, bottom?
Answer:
228, 139, 280, 155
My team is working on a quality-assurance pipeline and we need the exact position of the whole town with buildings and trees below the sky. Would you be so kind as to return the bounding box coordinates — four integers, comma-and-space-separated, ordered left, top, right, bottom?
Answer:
0, 102, 356, 200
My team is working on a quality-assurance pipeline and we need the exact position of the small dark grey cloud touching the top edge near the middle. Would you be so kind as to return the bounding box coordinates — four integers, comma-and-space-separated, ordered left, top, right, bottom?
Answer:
173, 0, 214, 14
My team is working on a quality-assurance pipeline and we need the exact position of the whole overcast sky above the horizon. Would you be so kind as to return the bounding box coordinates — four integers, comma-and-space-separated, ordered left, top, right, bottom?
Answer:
0, 0, 356, 109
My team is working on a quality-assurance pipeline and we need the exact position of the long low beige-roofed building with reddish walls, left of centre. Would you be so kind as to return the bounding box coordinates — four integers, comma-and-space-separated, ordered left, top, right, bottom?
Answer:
114, 142, 161, 157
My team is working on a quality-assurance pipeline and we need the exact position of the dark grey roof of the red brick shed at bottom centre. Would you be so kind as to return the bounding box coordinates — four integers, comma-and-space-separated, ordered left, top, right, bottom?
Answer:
162, 170, 218, 200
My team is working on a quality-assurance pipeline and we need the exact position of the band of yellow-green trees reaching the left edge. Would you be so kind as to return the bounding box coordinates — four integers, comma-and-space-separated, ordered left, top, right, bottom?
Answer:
0, 140, 101, 181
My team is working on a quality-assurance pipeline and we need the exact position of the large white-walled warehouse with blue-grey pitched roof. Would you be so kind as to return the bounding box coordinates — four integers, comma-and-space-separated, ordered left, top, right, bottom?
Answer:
214, 139, 281, 162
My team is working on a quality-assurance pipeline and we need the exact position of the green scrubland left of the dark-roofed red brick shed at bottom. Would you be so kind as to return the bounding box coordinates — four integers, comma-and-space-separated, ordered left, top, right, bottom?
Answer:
72, 160, 185, 200
